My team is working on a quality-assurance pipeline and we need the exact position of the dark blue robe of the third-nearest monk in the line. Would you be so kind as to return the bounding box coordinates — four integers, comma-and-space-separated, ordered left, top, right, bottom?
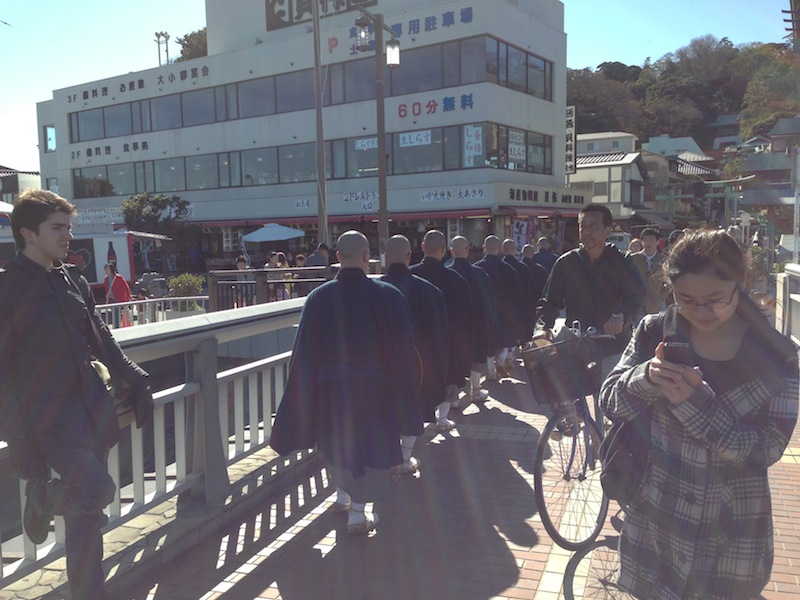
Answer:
411, 256, 475, 386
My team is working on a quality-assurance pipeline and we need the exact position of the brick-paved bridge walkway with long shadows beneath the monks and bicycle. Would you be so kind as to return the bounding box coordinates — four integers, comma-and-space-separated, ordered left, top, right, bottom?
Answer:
118, 356, 800, 600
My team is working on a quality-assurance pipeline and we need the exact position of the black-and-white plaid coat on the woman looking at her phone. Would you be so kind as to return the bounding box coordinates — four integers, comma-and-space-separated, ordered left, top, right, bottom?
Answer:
601, 304, 798, 600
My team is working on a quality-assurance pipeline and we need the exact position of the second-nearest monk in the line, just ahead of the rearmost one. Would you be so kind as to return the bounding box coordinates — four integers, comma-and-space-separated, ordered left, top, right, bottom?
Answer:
381, 235, 448, 473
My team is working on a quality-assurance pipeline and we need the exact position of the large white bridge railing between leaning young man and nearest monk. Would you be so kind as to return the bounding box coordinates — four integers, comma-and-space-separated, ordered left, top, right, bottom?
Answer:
0, 298, 310, 588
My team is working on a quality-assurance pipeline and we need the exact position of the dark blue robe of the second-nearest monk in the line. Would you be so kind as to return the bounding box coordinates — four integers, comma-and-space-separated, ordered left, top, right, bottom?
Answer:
381, 264, 448, 421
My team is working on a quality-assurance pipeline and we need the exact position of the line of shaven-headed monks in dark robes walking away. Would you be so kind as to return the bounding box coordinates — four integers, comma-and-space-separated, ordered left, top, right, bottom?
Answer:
270, 230, 547, 534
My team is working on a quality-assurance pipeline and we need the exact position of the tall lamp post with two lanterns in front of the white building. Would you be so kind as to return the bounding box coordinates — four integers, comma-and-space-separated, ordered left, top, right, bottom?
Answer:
356, 7, 400, 258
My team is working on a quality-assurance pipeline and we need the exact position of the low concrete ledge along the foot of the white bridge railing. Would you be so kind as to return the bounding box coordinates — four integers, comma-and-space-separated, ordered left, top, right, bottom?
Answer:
0, 448, 324, 600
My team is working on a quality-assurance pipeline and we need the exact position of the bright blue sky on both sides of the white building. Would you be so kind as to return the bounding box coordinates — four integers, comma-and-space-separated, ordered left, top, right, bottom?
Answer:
0, 0, 790, 171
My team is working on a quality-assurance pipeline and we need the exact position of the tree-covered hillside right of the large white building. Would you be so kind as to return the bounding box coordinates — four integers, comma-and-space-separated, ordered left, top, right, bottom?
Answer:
567, 35, 800, 148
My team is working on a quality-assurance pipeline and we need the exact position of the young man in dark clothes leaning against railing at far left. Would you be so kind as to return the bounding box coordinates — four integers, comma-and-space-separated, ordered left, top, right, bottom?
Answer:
0, 190, 153, 600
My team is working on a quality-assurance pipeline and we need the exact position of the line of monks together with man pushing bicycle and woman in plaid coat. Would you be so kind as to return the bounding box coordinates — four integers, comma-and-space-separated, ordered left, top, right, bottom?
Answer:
271, 204, 798, 600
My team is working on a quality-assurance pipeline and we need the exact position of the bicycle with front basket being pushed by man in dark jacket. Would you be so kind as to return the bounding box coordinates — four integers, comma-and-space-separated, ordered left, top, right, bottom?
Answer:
522, 323, 613, 551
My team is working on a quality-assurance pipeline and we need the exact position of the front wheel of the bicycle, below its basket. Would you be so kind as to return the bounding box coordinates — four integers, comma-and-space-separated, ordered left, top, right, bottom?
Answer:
533, 410, 608, 550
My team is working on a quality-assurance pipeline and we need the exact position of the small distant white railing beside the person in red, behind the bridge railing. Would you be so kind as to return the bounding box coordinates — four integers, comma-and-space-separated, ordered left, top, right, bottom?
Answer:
97, 296, 208, 329
